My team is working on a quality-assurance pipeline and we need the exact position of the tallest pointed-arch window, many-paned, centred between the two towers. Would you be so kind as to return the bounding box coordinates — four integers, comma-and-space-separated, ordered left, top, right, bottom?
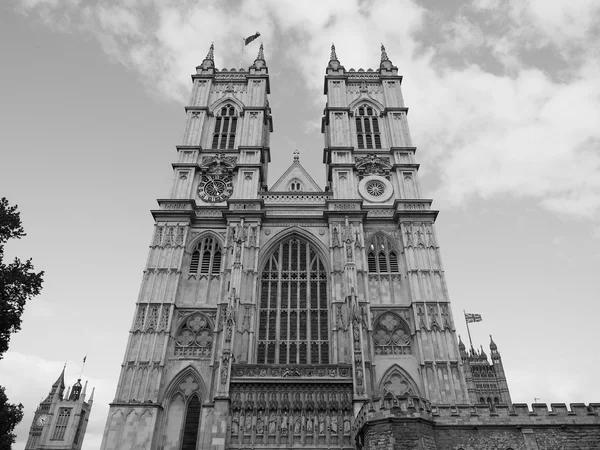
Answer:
257, 237, 329, 364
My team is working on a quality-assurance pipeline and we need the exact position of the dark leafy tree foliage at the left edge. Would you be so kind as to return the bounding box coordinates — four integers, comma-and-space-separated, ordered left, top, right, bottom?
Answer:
0, 197, 44, 450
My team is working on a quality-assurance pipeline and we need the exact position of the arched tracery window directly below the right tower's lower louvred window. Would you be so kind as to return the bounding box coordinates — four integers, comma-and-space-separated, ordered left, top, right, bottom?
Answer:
373, 312, 411, 355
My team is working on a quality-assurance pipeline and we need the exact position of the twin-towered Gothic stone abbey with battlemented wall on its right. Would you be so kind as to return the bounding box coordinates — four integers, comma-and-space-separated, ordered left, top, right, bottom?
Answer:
102, 45, 600, 450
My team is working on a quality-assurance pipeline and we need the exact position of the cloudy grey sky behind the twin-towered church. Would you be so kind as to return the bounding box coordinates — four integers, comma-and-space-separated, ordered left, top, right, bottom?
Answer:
0, 0, 600, 450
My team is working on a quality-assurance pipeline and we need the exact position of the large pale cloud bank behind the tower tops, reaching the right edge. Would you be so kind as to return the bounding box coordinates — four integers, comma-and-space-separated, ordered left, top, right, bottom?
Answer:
11, 0, 600, 218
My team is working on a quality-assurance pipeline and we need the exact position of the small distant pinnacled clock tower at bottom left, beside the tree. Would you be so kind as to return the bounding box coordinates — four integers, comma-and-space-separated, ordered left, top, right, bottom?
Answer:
25, 368, 94, 450
